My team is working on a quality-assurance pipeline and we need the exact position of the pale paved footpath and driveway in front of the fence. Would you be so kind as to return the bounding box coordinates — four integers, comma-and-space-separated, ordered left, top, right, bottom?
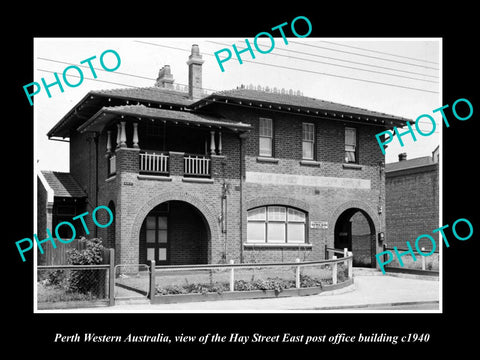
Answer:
43, 271, 440, 313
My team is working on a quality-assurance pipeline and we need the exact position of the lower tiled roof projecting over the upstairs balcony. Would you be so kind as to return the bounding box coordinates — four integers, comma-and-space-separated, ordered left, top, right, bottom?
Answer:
77, 105, 251, 132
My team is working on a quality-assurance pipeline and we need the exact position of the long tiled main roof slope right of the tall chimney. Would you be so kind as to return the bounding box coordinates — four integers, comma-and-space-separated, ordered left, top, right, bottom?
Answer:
191, 88, 412, 122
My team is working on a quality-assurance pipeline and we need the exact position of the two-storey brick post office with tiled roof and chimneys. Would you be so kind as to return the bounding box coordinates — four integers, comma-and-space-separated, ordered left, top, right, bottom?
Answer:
39, 45, 409, 266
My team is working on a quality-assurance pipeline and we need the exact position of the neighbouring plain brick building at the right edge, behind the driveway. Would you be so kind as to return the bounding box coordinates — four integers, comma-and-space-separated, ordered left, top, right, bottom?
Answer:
385, 146, 440, 251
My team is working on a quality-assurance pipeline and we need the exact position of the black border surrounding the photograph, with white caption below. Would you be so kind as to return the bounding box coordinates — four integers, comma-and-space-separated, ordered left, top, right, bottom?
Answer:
6, 2, 480, 357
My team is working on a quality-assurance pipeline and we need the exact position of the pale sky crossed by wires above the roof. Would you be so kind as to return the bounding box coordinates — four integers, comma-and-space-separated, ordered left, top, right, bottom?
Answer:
32, 34, 443, 172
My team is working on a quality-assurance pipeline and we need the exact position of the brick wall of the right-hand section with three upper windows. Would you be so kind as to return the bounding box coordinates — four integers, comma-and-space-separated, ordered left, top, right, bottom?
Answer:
208, 104, 385, 263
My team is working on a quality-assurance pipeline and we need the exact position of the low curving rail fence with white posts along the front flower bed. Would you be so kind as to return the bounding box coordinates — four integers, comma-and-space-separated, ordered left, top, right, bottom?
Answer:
149, 252, 353, 299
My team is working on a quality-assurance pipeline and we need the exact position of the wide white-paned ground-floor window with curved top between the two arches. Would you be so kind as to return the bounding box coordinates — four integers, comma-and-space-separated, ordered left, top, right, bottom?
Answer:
247, 205, 307, 244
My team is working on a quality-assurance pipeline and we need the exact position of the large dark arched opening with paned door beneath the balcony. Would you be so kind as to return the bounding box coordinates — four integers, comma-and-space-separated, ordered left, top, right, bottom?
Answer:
139, 200, 210, 265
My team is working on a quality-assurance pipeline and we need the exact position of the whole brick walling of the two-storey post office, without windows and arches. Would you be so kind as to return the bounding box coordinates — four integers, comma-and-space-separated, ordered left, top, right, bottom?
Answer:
71, 101, 385, 263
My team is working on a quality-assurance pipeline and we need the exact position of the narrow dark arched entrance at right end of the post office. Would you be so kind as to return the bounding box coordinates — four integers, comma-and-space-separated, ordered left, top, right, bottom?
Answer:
334, 208, 376, 267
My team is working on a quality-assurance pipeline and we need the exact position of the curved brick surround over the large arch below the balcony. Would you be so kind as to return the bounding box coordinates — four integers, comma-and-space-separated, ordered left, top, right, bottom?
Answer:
130, 191, 221, 258
